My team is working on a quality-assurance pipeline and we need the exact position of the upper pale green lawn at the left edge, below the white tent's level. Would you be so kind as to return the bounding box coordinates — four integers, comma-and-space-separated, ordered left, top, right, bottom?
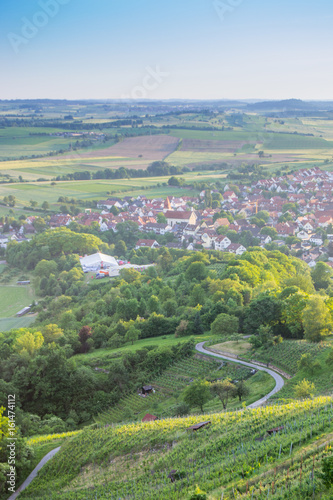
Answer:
0, 285, 35, 318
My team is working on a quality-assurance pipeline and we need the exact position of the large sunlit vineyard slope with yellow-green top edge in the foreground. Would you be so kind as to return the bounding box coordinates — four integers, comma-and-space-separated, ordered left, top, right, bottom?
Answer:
20, 397, 333, 500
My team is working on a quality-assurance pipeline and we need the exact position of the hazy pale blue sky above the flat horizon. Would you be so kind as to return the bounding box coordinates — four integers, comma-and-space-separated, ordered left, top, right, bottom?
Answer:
0, 0, 333, 99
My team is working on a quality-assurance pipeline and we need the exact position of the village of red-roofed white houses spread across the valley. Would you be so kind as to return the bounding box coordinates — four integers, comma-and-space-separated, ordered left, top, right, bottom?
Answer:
0, 167, 333, 267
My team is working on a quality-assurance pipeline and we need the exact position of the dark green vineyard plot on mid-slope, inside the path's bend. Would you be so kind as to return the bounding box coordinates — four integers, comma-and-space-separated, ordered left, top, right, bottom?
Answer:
96, 357, 251, 424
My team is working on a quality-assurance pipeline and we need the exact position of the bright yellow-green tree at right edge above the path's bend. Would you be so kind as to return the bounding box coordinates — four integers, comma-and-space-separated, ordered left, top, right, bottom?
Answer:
302, 295, 333, 342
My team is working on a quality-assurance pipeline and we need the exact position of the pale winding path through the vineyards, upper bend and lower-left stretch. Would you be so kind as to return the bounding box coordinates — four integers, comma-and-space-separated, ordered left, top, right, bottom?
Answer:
8, 342, 284, 500
